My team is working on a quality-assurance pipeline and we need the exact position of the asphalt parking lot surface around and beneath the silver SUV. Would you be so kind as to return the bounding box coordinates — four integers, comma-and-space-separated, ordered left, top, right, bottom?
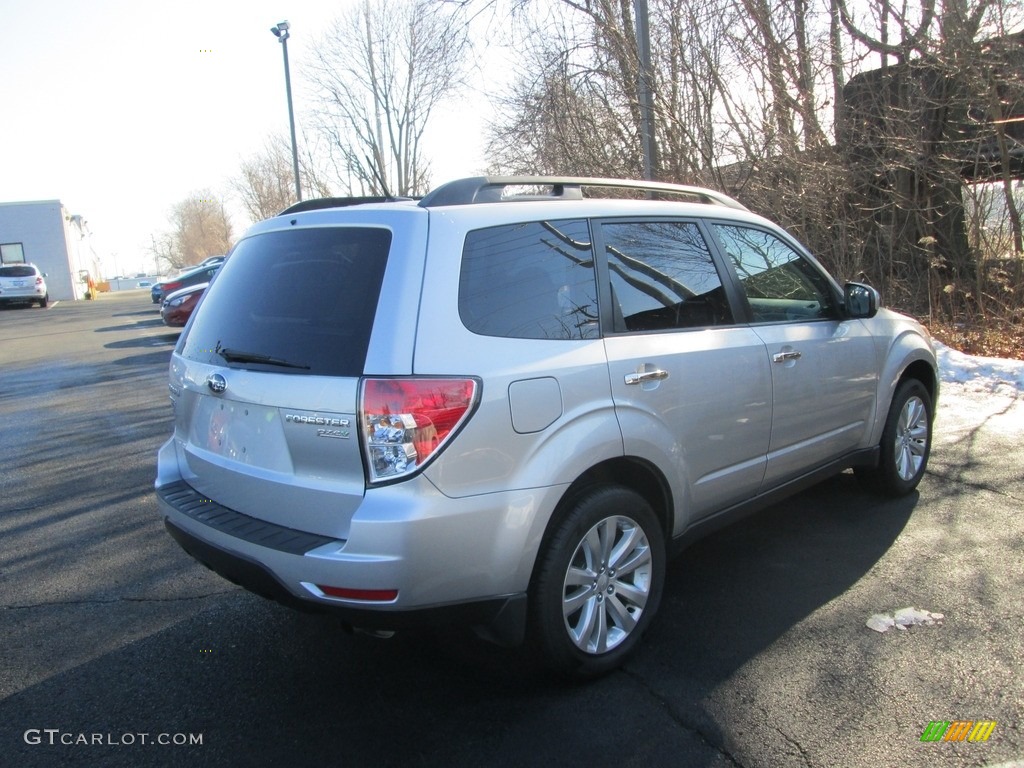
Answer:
0, 291, 1024, 768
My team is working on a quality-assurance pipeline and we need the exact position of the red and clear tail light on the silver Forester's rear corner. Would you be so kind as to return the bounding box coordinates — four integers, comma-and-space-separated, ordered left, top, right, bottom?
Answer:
359, 378, 478, 482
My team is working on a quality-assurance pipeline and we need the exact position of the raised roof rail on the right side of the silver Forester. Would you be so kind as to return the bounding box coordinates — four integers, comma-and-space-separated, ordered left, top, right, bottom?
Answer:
411, 176, 748, 211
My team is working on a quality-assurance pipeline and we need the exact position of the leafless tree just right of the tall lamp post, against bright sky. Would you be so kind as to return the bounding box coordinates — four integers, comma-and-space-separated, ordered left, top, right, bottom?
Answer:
311, 0, 469, 196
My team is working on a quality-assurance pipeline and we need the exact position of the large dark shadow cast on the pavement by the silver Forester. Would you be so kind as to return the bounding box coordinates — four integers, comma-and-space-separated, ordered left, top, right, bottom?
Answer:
0, 475, 914, 768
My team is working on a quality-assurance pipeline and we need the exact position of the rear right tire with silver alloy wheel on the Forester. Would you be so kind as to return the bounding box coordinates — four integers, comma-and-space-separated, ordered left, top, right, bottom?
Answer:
528, 485, 666, 680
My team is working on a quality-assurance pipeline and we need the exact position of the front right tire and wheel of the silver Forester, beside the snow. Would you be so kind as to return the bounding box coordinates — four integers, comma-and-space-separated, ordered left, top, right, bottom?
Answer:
856, 379, 933, 497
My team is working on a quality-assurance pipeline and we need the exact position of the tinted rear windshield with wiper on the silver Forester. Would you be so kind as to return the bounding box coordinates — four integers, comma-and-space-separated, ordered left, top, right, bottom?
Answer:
178, 227, 391, 376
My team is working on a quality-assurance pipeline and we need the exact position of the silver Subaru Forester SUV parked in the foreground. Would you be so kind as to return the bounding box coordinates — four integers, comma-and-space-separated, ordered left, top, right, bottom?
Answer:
156, 177, 938, 678
